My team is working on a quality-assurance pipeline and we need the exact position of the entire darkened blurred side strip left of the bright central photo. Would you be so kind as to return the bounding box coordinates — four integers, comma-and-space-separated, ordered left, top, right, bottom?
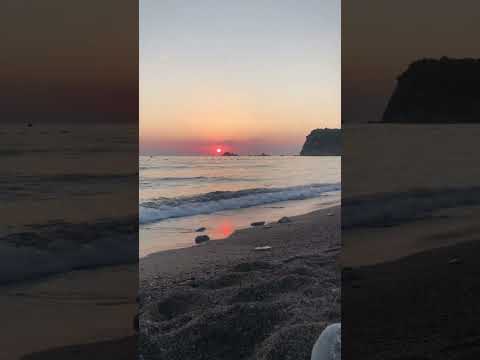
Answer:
0, 0, 139, 360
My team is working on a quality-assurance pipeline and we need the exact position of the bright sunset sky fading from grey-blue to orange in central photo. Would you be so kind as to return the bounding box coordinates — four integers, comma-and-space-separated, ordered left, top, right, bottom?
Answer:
140, 0, 340, 154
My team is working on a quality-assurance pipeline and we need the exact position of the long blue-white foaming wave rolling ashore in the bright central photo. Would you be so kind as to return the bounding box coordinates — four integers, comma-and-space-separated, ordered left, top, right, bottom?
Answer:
139, 183, 341, 224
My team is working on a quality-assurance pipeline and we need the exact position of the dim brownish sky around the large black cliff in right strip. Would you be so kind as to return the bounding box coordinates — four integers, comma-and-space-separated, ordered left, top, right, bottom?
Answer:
342, 0, 480, 123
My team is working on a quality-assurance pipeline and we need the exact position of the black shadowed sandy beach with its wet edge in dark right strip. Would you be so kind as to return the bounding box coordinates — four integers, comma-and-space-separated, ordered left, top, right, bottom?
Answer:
342, 222, 480, 360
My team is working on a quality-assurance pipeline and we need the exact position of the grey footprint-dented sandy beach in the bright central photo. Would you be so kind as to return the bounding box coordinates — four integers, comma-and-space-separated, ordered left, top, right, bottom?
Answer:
139, 206, 341, 360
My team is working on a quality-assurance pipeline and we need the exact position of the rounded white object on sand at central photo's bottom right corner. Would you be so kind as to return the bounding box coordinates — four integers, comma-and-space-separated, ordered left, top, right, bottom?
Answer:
311, 323, 342, 360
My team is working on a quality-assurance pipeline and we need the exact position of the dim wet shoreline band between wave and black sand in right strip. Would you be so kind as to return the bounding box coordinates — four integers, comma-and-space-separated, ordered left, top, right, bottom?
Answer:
340, 205, 480, 268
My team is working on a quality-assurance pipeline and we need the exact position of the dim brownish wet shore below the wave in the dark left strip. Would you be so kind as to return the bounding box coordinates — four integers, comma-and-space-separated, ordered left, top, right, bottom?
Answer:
0, 265, 138, 360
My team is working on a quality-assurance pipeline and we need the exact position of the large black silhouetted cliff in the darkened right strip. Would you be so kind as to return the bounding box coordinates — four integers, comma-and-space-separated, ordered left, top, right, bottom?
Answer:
382, 57, 480, 123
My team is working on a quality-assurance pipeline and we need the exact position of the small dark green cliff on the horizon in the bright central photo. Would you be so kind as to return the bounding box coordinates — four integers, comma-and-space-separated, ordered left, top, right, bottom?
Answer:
300, 129, 342, 156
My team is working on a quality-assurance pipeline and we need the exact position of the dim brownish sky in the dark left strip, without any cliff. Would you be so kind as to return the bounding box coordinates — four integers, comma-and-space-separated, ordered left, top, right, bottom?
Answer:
0, 0, 139, 124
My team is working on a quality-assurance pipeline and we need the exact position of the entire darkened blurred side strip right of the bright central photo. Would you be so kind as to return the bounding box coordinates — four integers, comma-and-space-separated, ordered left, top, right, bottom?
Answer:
342, 0, 480, 360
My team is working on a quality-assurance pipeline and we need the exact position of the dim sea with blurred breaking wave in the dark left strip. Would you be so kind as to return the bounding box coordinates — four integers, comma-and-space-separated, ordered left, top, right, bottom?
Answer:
0, 121, 138, 283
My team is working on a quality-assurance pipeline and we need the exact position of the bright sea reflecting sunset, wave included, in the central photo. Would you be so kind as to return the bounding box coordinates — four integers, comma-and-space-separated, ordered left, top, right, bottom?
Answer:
139, 156, 341, 256
